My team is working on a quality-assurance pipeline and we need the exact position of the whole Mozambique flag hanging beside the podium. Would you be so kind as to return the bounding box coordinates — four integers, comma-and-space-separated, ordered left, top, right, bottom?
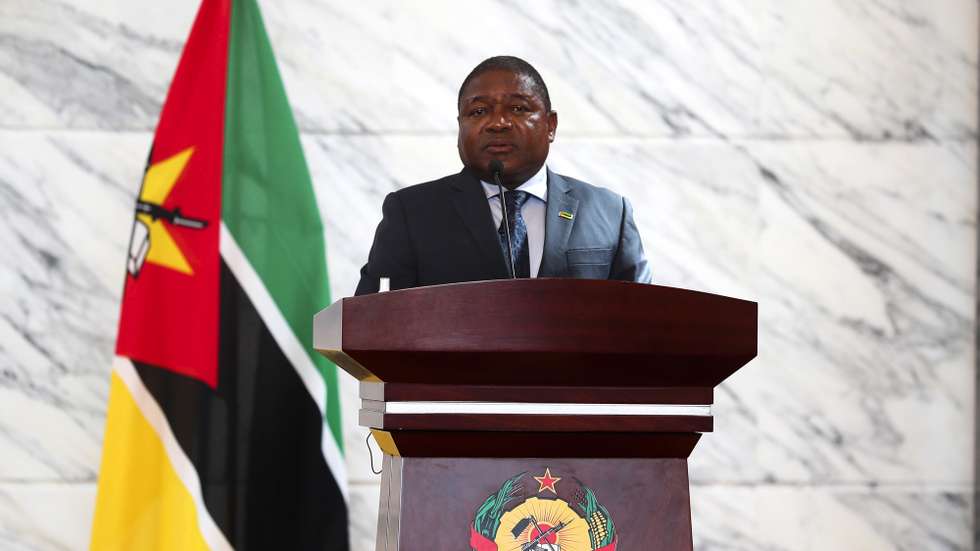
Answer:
91, 0, 348, 551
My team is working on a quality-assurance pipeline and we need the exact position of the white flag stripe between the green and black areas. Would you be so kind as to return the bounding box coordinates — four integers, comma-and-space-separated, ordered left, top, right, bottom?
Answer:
221, 222, 348, 501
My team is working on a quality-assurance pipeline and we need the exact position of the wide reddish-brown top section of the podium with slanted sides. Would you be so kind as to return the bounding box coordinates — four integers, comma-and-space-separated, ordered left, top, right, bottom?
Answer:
314, 279, 758, 388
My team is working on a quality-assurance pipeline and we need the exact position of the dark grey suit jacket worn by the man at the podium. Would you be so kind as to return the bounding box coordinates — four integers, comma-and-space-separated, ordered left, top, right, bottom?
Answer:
356, 169, 651, 295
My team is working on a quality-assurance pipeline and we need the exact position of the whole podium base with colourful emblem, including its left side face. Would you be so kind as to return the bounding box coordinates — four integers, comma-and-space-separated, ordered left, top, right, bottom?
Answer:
376, 458, 693, 551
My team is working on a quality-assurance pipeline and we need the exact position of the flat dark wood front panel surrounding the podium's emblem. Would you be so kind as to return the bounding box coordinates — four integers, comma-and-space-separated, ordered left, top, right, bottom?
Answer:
388, 458, 692, 551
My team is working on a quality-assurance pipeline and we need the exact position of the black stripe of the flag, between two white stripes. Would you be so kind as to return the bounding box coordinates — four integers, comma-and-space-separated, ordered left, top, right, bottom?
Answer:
134, 262, 348, 551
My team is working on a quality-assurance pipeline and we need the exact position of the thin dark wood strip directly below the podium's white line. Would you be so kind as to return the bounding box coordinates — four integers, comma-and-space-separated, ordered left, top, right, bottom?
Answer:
358, 409, 713, 433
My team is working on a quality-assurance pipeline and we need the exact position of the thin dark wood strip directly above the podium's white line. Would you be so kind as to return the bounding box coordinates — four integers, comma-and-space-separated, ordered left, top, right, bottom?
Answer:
360, 381, 714, 405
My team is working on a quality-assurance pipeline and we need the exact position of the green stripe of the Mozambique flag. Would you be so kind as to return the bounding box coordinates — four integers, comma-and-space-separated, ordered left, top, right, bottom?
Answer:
222, 0, 343, 449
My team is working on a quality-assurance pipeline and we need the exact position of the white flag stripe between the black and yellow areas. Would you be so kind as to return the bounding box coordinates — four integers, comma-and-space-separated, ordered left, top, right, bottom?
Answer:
112, 356, 233, 551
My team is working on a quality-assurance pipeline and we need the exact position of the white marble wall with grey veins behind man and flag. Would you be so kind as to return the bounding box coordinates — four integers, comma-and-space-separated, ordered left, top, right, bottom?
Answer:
0, 0, 978, 551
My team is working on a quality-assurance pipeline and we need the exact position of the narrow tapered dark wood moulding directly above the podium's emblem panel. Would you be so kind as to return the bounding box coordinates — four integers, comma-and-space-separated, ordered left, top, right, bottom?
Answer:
380, 431, 701, 458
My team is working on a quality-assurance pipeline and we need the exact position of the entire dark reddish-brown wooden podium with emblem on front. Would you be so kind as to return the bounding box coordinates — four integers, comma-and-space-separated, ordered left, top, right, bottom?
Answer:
314, 279, 757, 551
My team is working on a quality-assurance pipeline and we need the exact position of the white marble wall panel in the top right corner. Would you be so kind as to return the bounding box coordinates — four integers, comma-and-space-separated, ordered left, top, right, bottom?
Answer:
752, 0, 978, 140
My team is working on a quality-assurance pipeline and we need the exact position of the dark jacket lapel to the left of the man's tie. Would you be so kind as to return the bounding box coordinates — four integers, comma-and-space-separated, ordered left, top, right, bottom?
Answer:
451, 169, 508, 278
